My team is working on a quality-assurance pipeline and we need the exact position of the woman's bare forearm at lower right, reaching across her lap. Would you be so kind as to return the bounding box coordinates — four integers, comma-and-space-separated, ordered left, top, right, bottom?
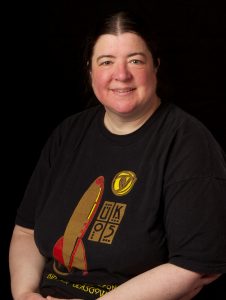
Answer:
98, 263, 220, 300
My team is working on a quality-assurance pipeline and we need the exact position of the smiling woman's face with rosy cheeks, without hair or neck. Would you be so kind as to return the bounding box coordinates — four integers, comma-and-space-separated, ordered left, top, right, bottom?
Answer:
90, 33, 157, 116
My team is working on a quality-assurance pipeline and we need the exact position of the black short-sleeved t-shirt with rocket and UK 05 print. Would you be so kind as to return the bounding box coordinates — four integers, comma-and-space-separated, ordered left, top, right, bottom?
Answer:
16, 103, 226, 299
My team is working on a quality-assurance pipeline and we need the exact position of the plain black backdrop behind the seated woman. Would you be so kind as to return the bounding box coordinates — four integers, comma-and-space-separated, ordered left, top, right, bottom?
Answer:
1, 0, 226, 299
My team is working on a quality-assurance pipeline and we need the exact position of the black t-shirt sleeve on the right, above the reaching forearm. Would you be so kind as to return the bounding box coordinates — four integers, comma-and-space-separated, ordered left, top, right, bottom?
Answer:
164, 118, 226, 273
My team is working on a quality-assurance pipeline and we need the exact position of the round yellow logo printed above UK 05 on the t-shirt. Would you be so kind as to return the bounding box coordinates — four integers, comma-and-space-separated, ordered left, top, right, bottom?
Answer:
111, 171, 137, 196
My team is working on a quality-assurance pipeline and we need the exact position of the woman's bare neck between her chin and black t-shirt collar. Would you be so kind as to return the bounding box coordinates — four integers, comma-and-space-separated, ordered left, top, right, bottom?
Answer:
104, 97, 161, 135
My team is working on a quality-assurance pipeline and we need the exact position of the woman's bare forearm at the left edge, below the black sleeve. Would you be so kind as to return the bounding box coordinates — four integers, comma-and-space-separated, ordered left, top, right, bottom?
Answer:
9, 225, 45, 300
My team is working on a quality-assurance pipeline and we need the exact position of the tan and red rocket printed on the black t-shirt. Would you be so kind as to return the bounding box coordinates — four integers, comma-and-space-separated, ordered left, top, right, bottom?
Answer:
53, 176, 104, 274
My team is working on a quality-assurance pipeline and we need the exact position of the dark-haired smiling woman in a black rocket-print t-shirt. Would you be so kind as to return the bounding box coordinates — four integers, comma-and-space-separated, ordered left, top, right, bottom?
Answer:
10, 12, 226, 300
